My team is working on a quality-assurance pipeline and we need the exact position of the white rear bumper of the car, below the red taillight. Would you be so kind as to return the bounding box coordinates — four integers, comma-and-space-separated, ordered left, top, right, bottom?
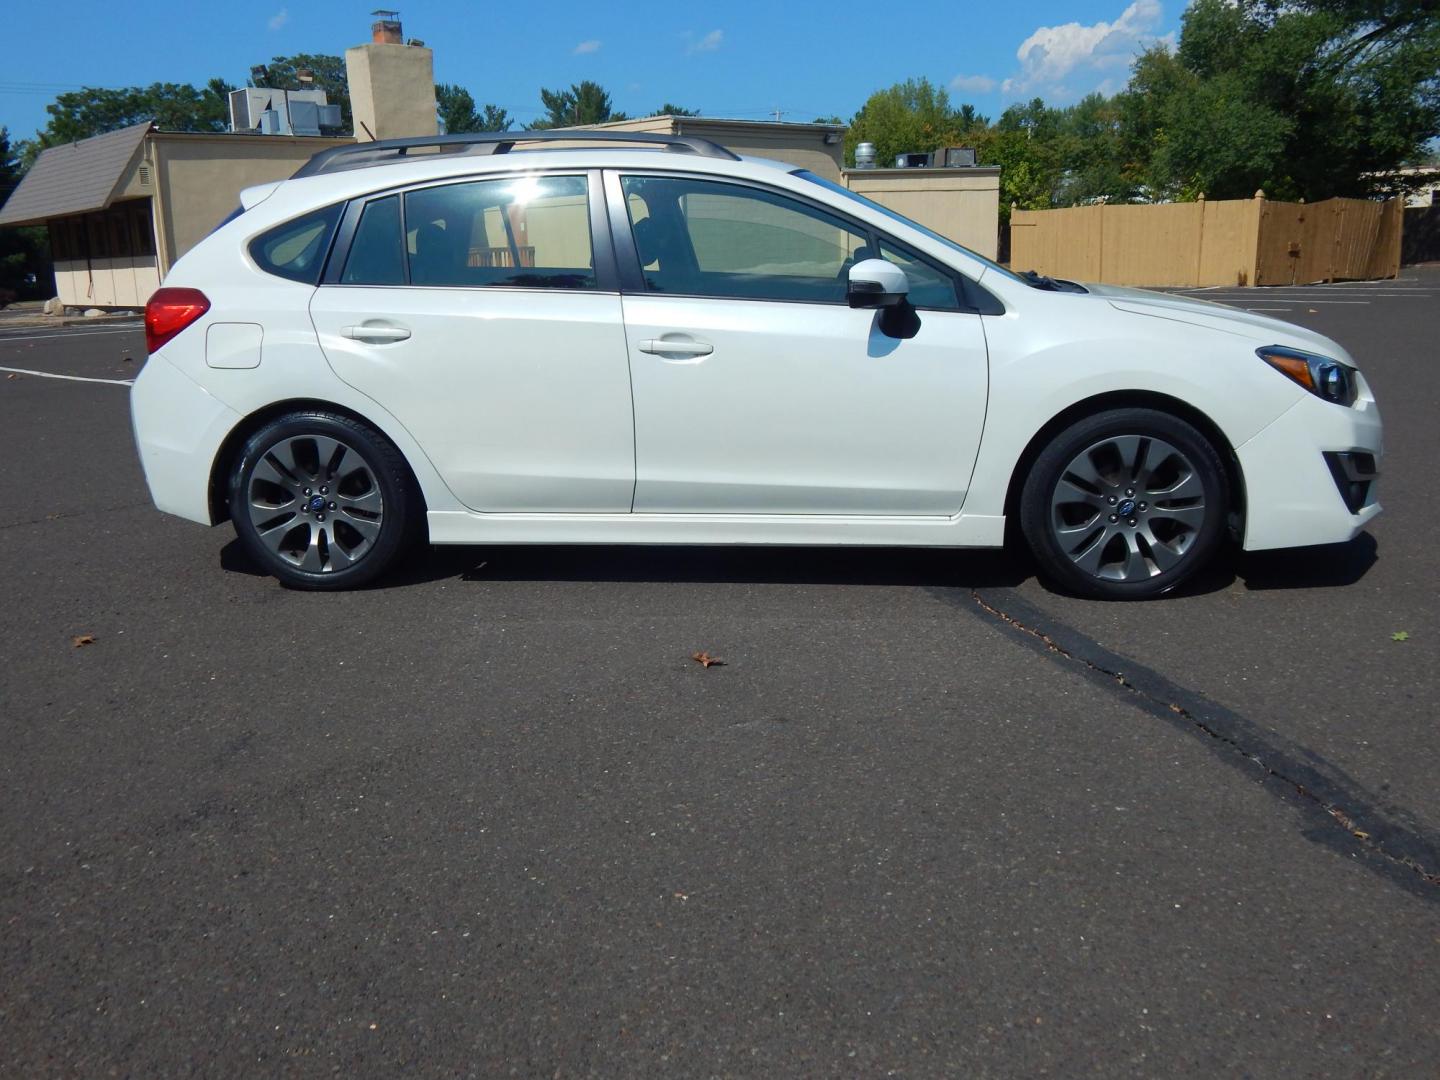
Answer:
130, 353, 240, 526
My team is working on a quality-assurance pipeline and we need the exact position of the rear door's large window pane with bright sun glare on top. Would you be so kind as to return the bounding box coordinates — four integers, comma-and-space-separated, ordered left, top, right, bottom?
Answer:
405, 176, 595, 289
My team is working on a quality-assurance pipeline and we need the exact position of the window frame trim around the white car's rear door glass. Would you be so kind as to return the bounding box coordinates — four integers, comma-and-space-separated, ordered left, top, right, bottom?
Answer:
320, 168, 621, 295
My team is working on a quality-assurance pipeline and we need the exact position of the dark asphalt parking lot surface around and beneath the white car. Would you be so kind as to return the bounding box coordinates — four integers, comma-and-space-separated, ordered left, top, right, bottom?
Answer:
8, 269, 1440, 1077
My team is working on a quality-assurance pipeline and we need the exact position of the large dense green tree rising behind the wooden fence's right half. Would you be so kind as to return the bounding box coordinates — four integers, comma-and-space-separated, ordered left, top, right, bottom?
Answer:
1120, 0, 1440, 200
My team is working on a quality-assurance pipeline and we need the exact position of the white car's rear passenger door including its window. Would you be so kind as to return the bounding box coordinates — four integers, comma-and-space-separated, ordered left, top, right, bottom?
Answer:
310, 173, 635, 513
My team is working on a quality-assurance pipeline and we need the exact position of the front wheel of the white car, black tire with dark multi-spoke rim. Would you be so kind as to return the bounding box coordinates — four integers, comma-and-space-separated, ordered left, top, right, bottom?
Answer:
1020, 409, 1230, 600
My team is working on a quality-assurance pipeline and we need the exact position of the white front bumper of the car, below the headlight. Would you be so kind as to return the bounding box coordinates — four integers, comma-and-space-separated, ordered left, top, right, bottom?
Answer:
1236, 393, 1381, 552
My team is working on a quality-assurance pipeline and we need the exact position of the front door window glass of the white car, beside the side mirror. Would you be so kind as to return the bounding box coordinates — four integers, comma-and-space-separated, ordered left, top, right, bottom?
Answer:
622, 176, 871, 304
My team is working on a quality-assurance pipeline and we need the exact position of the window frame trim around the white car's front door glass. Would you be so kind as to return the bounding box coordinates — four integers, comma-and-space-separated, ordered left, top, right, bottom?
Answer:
603, 168, 1005, 315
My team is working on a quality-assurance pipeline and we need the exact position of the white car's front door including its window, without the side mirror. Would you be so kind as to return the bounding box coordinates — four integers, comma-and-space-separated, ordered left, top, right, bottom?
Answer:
606, 170, 988, 516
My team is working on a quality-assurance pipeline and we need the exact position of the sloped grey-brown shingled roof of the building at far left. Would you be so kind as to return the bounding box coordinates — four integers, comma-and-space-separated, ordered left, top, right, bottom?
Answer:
0, 120, 151, 226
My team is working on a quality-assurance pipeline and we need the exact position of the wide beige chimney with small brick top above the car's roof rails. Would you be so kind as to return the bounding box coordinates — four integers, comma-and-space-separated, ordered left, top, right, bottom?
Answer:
346, 10, 439, 143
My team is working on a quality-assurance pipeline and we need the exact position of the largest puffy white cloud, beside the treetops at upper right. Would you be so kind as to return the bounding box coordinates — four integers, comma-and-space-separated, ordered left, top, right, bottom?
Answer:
1001, 0, 1166, 96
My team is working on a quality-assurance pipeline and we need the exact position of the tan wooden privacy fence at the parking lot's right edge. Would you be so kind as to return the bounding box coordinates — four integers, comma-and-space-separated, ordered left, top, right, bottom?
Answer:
1009, 194, 1404, 287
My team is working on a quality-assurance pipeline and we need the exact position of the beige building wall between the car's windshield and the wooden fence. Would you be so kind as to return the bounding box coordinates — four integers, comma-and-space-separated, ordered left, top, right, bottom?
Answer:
845, 167, 999, 259
